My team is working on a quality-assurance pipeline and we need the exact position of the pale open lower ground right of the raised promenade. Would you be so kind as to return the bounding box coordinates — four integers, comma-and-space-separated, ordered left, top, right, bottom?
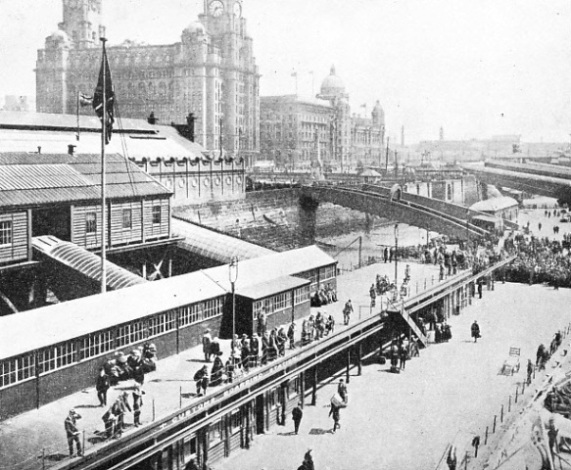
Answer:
214, 284, 571, 470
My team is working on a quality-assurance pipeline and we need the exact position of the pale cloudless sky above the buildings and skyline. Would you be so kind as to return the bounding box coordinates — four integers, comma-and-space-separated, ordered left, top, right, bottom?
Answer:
0, 0, 571, 143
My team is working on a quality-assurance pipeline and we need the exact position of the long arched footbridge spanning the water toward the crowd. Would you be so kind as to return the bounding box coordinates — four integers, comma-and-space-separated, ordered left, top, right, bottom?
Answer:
302, 184, 489, 239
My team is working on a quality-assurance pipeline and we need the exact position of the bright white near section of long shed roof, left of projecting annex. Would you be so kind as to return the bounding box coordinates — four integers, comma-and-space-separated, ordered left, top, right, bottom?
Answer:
0, 271, 226, 359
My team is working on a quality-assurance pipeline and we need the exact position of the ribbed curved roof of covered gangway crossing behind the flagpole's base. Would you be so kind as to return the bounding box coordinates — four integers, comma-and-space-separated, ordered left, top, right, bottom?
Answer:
32, 239, 147, 290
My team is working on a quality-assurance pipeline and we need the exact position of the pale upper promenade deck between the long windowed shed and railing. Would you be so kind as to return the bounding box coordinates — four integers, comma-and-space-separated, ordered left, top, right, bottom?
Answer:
0, 262, 438, 470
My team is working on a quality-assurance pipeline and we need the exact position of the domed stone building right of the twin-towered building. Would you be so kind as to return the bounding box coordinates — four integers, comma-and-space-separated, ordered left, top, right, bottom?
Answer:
260, 67, 385, 171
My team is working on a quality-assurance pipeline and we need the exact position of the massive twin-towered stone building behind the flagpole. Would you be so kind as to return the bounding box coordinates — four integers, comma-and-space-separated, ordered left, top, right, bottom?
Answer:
36, 0, 260, 155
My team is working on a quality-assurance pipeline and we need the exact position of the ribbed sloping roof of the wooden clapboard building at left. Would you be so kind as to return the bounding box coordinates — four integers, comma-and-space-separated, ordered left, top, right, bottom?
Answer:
0, 153, 172, 206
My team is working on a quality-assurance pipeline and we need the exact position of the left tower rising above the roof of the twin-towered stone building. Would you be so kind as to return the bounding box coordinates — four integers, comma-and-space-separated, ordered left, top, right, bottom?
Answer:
59, 0, 103, 49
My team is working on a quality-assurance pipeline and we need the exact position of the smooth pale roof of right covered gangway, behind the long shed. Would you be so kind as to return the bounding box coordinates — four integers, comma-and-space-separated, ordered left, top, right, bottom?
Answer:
171, 217, 274, 264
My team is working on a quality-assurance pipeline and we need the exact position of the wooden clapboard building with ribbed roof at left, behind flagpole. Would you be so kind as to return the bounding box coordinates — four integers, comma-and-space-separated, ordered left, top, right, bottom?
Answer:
0, 153, 172, 267
